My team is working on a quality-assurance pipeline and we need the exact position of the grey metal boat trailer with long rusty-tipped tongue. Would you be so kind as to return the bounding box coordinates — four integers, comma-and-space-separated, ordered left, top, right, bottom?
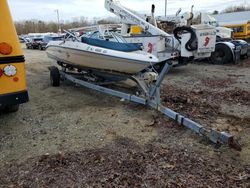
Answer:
49, 62, 241, 151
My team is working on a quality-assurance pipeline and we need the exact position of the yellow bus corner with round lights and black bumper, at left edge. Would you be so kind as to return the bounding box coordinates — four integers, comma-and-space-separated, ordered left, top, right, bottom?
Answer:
0, 0, 29, 112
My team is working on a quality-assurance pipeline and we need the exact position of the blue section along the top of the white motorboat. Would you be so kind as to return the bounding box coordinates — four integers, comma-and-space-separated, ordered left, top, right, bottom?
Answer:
81, 37, 141, 52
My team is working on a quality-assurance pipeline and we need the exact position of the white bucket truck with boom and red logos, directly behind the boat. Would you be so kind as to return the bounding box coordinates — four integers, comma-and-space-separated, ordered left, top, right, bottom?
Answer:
105, 0, 216, 66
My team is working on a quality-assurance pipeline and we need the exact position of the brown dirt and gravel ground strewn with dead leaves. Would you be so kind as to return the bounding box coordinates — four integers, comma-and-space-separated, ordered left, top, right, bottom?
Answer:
0, 44, 250, 187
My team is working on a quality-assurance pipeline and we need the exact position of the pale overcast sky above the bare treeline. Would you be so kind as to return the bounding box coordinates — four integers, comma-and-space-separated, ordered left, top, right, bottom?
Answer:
8, 0, 249, 21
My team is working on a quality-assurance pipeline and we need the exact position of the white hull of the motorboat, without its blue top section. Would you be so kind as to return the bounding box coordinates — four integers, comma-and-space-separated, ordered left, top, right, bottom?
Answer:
46, 41, 159, 74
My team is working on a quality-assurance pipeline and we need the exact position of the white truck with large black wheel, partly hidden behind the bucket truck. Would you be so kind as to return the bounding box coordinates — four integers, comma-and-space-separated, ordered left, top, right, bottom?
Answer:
157, 9, 248, 64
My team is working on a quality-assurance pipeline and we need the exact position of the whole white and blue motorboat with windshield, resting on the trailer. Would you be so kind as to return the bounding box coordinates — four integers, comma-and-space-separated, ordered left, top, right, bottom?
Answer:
46, 26, 159, 75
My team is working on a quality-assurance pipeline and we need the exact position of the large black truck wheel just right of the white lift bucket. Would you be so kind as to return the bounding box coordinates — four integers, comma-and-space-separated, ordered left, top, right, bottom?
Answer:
211, 44, 233, 65
